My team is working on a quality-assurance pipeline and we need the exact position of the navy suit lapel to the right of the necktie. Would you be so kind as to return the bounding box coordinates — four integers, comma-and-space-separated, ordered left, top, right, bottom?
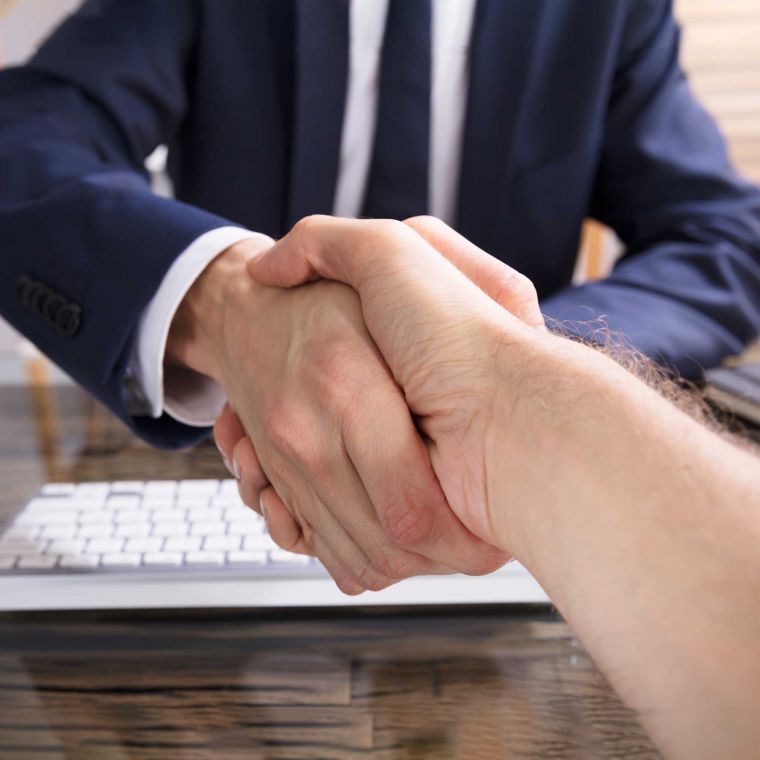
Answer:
457, 0, 544, 255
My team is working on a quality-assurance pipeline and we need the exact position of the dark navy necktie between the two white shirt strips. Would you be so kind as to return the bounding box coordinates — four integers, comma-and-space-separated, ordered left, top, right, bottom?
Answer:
363, 0, 431, 219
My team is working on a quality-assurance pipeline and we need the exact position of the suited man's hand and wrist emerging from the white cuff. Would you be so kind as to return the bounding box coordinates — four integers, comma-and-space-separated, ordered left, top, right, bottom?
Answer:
168, 238, 507, 593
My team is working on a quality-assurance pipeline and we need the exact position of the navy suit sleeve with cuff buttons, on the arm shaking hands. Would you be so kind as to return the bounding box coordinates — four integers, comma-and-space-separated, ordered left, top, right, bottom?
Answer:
0, 0, 236, 447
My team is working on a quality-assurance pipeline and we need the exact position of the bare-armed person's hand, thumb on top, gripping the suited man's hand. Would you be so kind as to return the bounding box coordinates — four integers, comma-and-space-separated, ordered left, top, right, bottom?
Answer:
223, 217, 544, 543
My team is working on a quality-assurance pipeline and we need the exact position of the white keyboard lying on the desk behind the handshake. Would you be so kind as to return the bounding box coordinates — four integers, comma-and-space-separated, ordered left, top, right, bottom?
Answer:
0, 480, 546, 610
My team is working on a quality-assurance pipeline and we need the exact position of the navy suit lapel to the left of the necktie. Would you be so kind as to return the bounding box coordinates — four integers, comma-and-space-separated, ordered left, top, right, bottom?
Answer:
287, 0, 349, 227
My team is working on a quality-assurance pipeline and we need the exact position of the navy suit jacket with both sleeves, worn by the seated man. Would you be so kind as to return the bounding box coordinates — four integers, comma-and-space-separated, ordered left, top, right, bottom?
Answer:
0, 0, 760, 446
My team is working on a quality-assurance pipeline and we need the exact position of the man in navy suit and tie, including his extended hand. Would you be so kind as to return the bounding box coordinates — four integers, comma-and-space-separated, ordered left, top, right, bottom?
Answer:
0, 0, 760, 588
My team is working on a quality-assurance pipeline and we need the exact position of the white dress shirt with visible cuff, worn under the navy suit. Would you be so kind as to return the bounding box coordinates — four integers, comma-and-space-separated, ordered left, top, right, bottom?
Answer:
131, 0, 475, 426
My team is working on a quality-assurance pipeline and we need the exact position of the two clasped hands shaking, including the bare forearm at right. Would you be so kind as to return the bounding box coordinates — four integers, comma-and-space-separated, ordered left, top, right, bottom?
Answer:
169, 217, 760, 758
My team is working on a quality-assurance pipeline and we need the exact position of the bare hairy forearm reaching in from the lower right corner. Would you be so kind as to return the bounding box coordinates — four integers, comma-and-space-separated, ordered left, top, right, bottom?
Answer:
487, 337, 760, 757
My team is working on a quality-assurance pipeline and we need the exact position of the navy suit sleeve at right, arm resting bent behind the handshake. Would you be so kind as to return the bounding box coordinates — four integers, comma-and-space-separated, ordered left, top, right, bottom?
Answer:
542, 0, 760, 377
